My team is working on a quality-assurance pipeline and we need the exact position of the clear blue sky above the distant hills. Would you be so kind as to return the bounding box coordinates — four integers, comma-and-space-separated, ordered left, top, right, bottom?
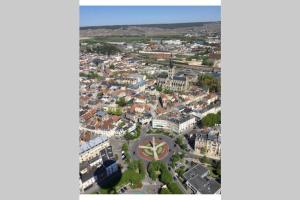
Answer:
80, 6, 221, 27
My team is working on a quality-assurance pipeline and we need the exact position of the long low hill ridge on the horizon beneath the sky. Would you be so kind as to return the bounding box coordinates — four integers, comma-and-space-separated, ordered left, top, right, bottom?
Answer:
80, 21, 221, 37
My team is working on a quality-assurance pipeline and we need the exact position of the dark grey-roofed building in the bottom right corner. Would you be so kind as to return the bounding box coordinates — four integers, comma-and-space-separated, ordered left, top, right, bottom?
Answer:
183, 164, 221, 194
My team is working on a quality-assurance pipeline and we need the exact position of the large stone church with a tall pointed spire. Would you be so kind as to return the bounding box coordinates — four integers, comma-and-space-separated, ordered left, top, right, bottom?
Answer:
158, 57, 189, 91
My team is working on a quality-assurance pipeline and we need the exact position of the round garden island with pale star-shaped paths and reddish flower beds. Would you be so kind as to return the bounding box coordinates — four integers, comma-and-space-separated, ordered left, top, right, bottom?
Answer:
132, 135, 174, 161
